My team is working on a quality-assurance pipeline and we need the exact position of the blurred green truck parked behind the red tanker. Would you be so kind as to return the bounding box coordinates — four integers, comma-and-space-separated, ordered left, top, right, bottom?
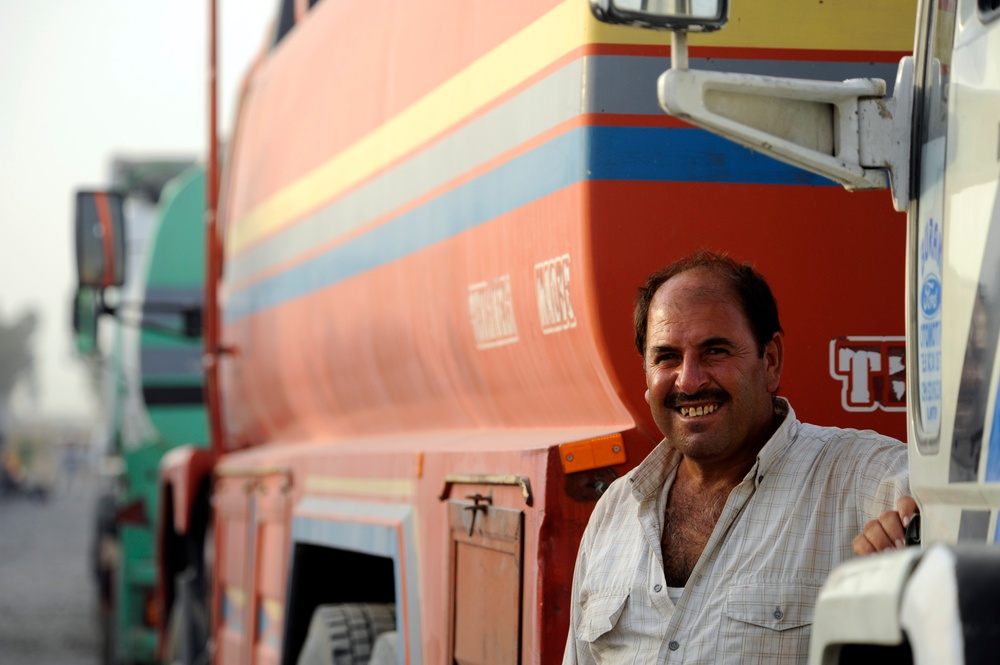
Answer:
77, 159, 208, 663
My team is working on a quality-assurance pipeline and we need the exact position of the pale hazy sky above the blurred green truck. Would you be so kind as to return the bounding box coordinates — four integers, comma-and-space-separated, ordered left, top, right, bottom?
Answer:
0, 0, 278, 416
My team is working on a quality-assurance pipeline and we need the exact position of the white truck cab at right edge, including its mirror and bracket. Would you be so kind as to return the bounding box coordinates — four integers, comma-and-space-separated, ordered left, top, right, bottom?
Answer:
594, 0, 1000, 663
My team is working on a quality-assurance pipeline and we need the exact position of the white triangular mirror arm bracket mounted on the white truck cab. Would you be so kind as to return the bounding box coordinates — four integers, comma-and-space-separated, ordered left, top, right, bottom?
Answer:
657, 58, 913, 210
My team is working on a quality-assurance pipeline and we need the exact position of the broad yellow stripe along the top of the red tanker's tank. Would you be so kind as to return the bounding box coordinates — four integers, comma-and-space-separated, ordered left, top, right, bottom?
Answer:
227, 0, 916, 254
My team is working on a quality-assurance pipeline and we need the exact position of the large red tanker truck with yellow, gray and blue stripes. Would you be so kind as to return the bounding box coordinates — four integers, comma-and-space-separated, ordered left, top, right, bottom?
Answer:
82, 0, 913, 664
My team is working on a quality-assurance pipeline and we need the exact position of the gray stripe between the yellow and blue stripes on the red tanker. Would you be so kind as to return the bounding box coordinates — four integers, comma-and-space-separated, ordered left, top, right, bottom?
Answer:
225, 56, 896, 283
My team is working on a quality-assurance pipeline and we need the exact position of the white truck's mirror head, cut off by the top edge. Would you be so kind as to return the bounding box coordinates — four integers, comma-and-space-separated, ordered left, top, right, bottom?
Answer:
590, 0, 729, 32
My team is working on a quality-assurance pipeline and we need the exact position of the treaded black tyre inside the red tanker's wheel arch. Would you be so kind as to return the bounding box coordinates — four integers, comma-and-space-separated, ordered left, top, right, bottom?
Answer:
298, 603, 396, 665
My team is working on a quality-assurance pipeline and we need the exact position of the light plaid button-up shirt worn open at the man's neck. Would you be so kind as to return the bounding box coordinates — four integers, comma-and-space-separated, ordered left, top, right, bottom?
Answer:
563, 399, 909, 665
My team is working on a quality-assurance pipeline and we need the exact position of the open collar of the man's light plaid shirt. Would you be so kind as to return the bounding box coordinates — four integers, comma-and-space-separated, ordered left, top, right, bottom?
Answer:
629, 397, 799, 502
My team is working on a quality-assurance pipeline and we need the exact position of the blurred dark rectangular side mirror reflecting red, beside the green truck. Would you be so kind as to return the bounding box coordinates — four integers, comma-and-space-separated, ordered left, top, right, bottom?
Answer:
76, 192, 125, 288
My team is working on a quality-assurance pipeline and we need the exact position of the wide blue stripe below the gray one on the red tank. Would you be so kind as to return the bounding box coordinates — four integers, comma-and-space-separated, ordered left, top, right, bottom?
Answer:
225, 126, 835, 322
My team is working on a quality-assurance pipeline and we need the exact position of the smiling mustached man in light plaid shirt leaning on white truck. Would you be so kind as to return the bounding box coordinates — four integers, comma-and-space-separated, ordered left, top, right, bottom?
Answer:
563, 252, 916, 665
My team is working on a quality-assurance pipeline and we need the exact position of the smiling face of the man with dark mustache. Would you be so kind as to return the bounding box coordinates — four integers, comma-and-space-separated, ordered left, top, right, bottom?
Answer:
644, 269, 784, 462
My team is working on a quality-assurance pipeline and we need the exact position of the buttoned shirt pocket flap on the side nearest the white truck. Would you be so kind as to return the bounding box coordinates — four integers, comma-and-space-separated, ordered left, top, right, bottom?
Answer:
726, 581, 822, 632
